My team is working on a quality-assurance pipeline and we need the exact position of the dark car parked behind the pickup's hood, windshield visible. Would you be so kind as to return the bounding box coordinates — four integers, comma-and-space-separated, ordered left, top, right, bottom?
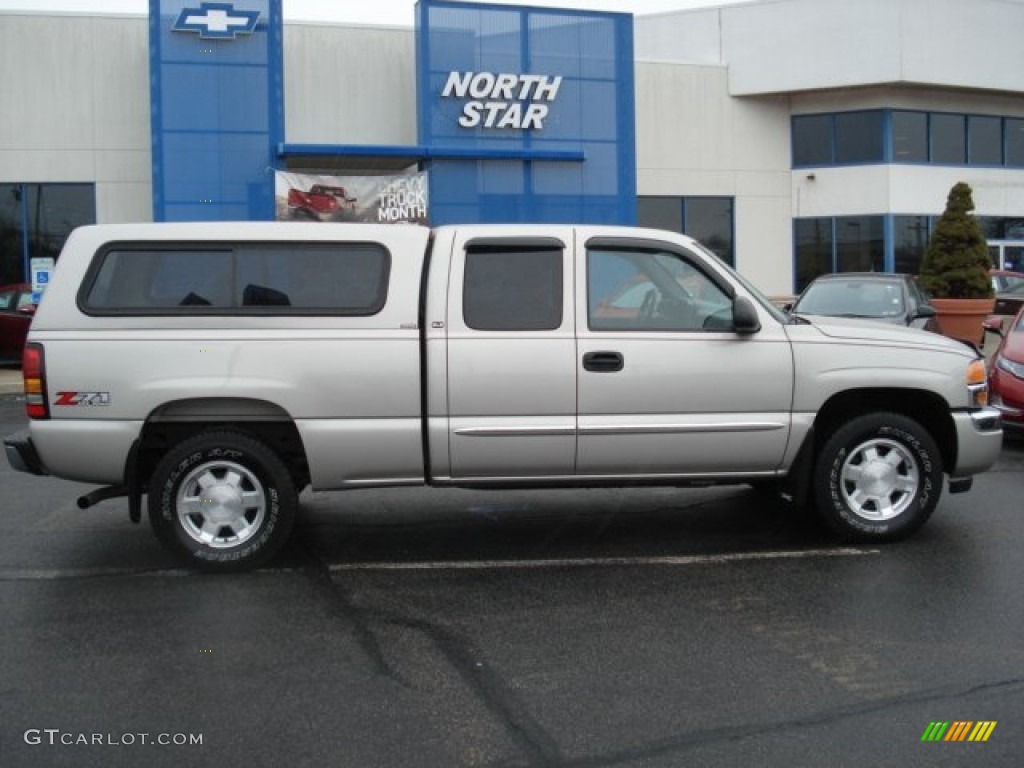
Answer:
788, 272, 939, 333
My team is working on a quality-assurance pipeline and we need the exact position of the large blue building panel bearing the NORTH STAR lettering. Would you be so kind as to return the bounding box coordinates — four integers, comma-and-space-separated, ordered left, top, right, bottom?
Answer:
416, 0, 636, 224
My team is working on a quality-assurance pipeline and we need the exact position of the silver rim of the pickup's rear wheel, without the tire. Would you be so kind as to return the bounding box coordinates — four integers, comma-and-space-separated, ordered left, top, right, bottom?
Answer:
175, 461, 266, 549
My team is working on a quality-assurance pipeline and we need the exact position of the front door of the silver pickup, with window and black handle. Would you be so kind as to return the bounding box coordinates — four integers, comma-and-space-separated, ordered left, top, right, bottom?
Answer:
577, 239, 793, 477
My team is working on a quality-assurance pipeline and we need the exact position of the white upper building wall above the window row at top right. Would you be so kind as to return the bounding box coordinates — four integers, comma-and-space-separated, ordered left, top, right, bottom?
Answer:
636, 0, 1024, 96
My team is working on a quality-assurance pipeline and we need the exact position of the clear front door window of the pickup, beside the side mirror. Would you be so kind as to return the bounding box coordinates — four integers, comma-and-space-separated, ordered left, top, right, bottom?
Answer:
587, 249, 732, 331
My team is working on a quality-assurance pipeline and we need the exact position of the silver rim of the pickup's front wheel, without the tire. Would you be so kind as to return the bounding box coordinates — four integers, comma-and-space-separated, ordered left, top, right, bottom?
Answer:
840, 438, 921, 521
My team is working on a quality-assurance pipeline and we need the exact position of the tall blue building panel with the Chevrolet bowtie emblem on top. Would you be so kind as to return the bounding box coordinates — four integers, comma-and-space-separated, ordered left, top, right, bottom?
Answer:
150, 0, 284, 221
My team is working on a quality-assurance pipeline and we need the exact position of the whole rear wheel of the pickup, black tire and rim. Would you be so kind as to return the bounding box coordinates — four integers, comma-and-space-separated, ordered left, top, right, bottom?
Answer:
148, 430, 298, 572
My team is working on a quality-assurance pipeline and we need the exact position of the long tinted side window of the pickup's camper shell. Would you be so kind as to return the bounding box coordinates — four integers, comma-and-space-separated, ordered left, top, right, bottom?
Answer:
80, 243, 390, 315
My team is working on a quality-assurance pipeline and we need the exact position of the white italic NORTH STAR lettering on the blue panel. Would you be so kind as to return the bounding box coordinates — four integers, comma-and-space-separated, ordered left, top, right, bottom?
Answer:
441, 72, 562, 131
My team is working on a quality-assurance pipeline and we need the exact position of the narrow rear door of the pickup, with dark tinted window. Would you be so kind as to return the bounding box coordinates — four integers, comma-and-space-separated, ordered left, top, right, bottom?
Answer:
446, 227, 577, 481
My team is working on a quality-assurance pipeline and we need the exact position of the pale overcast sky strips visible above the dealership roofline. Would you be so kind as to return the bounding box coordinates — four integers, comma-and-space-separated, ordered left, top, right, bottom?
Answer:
0, 0, 752, 27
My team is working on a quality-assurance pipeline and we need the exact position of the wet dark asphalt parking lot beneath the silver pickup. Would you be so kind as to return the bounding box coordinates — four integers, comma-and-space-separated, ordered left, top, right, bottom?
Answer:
0, 396, 1024, 768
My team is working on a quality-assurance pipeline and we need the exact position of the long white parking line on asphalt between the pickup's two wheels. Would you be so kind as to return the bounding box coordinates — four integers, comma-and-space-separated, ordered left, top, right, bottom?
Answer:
328, 547, 881, 571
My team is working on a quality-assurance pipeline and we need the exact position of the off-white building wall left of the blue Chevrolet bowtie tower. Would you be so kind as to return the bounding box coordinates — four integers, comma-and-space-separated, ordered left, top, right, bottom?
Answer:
0, 13, 153, 221
